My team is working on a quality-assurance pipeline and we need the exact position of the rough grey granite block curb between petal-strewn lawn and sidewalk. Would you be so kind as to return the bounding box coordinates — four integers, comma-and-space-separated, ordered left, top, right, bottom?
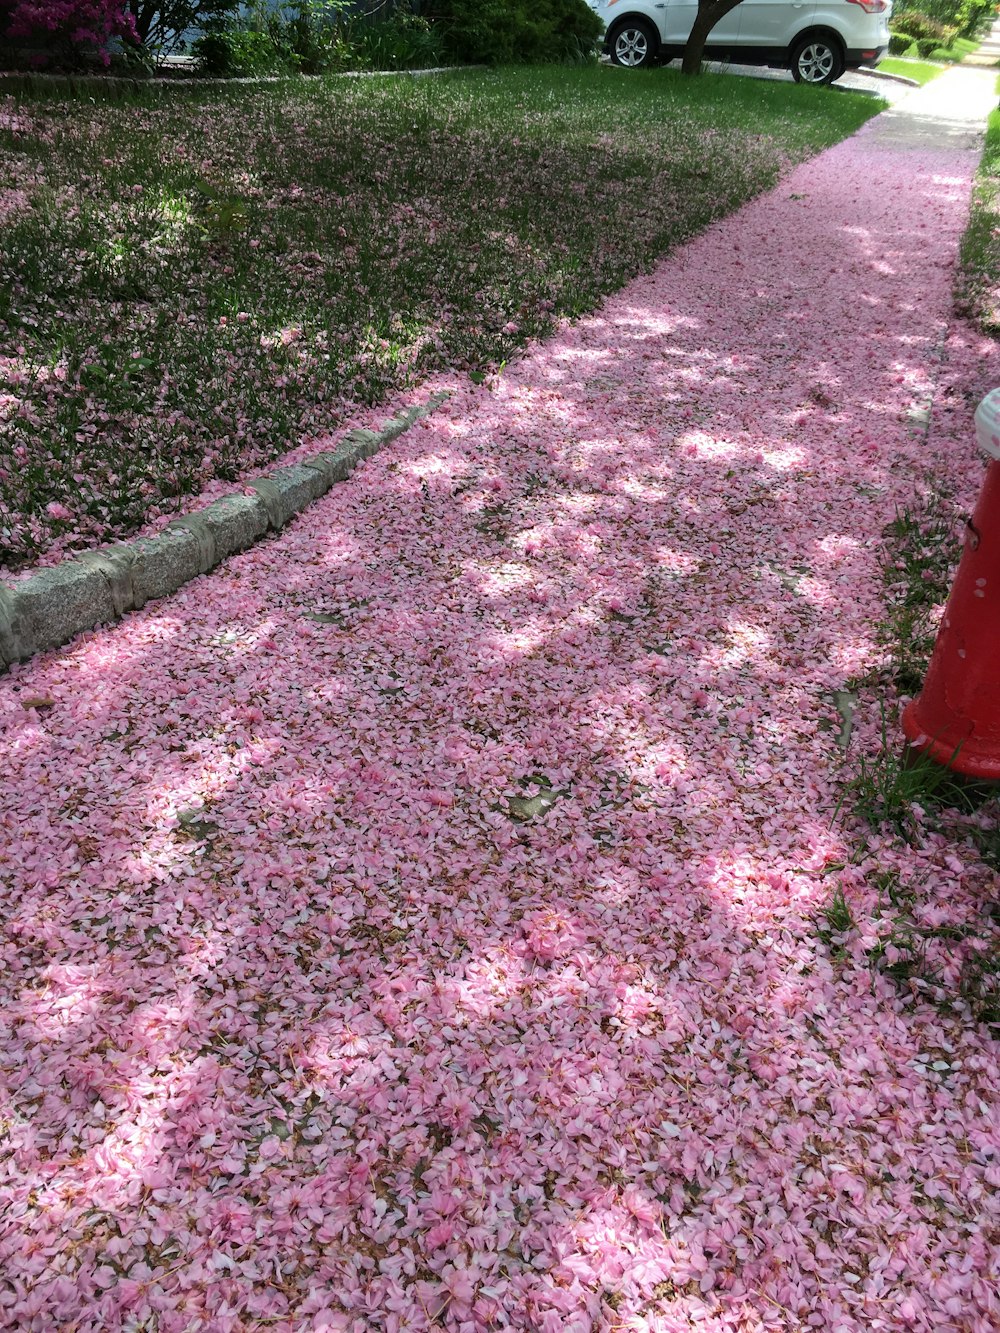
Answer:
0, 392, 448, 673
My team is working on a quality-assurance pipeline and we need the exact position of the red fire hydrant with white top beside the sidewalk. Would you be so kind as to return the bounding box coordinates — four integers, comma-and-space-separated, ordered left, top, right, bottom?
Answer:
903, 389, 1000, 781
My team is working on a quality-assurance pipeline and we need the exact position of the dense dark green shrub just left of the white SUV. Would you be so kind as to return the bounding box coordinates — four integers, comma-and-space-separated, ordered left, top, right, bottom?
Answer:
429, 0, 604, 65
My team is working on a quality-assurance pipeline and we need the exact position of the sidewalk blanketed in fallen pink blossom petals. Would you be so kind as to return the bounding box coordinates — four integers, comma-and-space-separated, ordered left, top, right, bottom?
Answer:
0, 72, 1000, 1333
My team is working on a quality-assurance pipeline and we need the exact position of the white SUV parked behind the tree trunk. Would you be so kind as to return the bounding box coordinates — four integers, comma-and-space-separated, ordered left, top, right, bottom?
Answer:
588, 0, 892, 84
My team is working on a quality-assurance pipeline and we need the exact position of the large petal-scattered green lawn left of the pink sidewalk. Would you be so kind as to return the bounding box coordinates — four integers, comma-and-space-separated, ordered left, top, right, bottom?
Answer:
0, 67, 883, 568
